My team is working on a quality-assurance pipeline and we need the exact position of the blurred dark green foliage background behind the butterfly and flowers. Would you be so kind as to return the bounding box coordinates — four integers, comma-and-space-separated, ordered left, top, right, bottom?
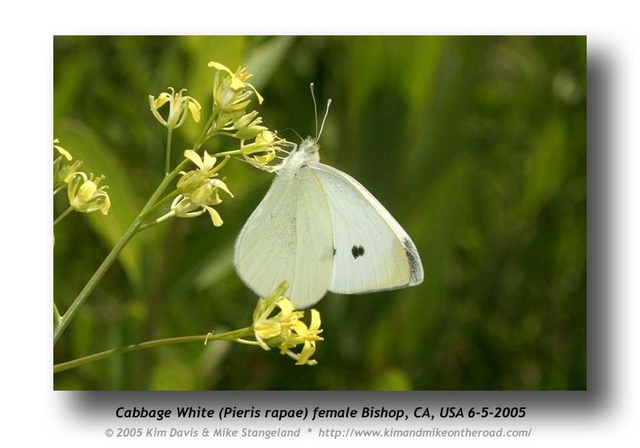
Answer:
53, 36, 587, 390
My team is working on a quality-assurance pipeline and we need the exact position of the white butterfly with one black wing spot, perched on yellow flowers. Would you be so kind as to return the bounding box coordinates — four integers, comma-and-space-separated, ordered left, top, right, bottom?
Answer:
234, 84, 424, 309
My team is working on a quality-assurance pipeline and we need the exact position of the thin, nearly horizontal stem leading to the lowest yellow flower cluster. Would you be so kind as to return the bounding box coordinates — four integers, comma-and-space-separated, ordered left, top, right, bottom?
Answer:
53, 327, 251, 373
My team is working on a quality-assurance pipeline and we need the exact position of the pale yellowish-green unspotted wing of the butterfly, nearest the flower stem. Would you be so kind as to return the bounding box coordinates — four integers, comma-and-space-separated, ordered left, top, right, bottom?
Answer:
235, 168, 333, 308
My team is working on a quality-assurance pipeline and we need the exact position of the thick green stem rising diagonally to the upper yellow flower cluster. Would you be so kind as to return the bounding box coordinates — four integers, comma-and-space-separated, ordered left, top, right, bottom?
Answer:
53, 159, 189, 344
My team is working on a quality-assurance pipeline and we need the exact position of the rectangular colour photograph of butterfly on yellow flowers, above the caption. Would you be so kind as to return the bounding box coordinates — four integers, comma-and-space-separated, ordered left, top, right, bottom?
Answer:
51, 34, 588, 392
